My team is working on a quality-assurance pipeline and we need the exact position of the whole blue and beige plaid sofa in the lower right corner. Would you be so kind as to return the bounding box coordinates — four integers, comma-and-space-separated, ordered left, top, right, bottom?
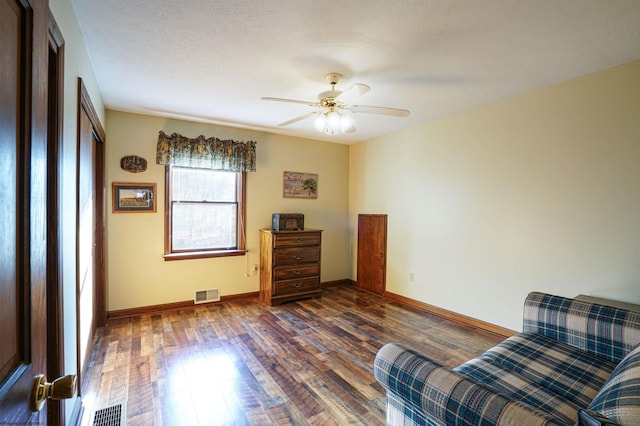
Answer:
374, 292, 640, 426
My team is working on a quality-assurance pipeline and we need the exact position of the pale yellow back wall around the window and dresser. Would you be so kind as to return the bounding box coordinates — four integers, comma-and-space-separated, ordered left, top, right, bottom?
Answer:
106, 111, 351, 311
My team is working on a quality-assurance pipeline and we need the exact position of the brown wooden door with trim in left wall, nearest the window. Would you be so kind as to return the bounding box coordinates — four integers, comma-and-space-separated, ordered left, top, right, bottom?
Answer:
76, 79, 106, 387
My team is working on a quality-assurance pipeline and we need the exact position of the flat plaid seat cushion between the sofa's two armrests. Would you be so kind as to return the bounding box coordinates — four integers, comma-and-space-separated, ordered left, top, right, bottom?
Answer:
454, 333, 615, 423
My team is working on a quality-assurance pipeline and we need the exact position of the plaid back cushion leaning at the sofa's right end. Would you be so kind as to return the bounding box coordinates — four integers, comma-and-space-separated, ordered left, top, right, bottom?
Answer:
589, 345, 640, 425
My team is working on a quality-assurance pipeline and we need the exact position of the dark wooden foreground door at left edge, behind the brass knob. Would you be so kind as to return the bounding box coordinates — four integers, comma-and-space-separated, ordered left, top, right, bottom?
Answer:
0, 0, 49, 425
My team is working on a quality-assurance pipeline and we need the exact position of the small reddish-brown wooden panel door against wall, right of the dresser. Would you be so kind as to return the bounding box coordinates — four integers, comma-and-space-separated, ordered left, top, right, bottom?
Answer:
357, 214, 387, 294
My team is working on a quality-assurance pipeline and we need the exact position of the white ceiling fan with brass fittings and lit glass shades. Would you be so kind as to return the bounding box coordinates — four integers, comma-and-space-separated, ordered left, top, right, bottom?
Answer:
260, 72, 409, 135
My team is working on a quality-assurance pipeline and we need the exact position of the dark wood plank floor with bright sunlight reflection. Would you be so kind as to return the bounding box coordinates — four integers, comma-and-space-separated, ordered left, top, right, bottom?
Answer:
83, 287, 502, 426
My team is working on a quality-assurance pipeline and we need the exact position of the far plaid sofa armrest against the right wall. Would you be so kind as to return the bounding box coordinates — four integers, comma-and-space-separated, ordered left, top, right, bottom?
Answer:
523, 292, 640, 363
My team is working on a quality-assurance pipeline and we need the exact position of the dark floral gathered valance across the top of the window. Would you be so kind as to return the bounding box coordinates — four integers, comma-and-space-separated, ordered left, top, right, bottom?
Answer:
156, 130, 256, 172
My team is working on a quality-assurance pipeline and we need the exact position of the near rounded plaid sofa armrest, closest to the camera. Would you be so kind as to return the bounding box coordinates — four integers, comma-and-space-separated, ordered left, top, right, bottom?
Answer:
374, 343, 555, 425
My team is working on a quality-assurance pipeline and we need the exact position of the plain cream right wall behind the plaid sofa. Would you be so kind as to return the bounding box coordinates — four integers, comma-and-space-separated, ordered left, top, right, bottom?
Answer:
349, 61, 640, 330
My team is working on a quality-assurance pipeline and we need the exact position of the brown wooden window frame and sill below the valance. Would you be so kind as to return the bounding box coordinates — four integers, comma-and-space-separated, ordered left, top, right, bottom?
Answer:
163, 165, 247, 260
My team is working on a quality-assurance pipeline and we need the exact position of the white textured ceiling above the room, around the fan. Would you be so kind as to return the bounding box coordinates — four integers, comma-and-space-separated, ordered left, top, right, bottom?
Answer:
72, 0, 640, 143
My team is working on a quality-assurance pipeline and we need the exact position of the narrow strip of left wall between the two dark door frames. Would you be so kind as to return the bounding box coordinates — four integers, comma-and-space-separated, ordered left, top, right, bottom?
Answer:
49, 0, 105, 422
